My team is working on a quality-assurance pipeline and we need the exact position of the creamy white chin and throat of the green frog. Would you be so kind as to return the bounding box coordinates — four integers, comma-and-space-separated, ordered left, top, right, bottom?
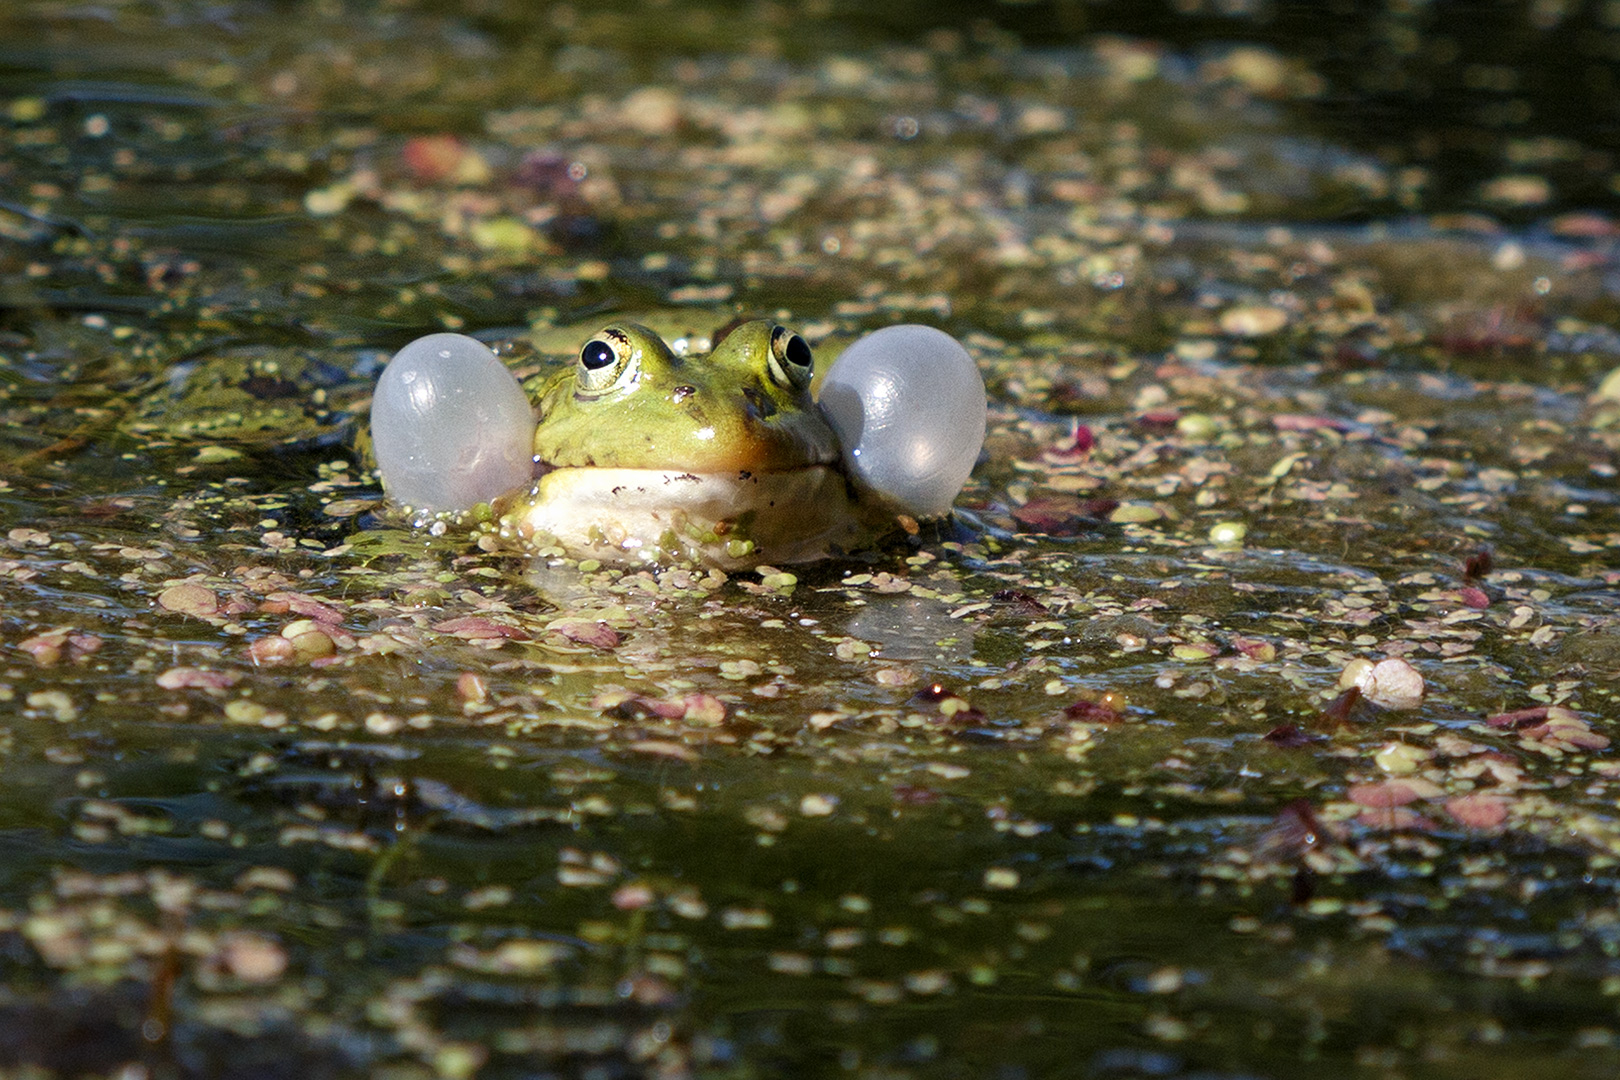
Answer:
502, 465, 873, 570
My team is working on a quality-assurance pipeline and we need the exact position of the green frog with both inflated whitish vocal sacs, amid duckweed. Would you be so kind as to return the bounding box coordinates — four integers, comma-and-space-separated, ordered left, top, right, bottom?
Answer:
371, 319, 987, 568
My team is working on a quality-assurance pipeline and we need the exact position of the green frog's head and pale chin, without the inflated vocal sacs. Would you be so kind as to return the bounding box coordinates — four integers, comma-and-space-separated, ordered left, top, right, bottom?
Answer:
497, 319, 896, 568
